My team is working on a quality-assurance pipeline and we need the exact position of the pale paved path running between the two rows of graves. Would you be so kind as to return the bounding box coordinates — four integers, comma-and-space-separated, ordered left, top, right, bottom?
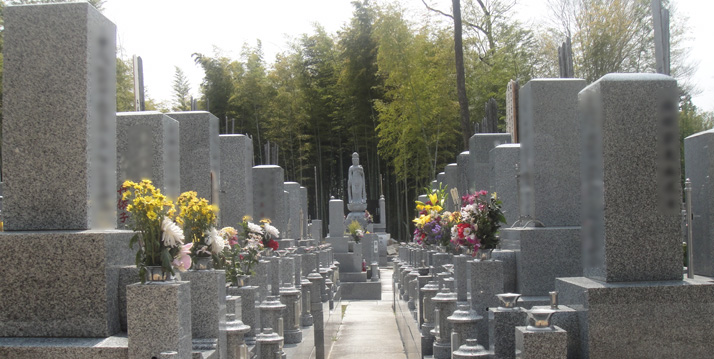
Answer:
325, 269, 406, 359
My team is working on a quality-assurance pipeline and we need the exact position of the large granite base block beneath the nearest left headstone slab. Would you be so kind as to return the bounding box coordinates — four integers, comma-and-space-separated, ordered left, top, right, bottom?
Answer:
0, 230, 135, 338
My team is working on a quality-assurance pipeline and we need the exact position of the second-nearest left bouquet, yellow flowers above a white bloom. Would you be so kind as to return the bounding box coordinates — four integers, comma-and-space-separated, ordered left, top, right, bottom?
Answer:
176, 191, 225, 269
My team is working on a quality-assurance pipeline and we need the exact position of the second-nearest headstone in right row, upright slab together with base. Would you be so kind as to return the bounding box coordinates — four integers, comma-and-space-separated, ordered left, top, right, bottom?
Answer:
501, 79, 585, 296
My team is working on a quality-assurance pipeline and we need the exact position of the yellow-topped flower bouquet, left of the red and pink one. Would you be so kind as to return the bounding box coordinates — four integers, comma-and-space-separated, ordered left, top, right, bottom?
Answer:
413, 188, 453, 247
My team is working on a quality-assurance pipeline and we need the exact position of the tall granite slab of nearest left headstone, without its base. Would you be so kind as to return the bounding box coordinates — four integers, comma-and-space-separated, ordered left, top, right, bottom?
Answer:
2, 3, 117, 231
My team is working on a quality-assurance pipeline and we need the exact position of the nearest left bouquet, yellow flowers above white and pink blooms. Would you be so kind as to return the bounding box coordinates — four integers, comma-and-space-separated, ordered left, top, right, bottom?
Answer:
121, 180, 193, 283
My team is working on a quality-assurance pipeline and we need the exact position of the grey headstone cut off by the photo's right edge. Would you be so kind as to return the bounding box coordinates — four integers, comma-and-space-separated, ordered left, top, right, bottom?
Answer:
684, 130, 714, 277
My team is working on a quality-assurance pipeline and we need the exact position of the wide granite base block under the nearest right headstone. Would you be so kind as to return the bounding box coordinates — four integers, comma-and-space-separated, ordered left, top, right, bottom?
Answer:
556, 276, 714, 359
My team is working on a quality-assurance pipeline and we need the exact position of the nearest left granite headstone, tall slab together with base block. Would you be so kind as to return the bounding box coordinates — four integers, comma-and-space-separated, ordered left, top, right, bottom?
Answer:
0, 3, 134, 340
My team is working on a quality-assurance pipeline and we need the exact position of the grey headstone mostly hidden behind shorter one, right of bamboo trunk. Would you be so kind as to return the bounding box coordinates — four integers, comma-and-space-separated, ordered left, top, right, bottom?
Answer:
469, 133, 511, 191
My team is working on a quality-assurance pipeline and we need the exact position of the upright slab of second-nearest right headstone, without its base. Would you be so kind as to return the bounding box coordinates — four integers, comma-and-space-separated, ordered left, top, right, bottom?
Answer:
518, 79, 586, 227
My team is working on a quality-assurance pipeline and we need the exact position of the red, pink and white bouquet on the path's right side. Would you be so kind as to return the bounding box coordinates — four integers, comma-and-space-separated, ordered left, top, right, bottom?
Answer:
451, 191, 506, 253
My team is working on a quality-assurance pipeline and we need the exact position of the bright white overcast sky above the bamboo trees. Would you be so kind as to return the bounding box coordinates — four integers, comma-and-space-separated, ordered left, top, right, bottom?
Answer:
104, 0, 714, 111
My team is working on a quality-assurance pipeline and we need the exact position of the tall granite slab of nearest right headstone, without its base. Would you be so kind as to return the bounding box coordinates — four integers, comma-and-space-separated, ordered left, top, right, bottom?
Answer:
579, 74, 682, 282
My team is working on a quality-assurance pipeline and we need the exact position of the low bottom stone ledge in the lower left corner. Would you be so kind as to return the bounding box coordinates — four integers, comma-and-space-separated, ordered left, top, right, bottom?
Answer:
0, 333, 129, 359
